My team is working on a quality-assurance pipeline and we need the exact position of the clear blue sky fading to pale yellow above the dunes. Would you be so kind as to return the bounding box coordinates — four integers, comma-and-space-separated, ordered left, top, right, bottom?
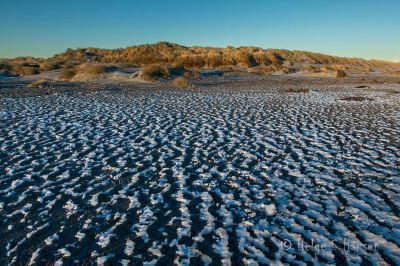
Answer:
0, 0, 400, 61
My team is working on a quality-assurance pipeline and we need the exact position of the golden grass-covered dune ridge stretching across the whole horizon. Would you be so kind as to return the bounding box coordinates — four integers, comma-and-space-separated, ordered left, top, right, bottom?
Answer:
0, 42, 400, 76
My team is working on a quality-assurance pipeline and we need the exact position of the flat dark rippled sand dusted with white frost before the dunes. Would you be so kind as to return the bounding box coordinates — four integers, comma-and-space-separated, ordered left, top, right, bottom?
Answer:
0, 77, 400, 265
